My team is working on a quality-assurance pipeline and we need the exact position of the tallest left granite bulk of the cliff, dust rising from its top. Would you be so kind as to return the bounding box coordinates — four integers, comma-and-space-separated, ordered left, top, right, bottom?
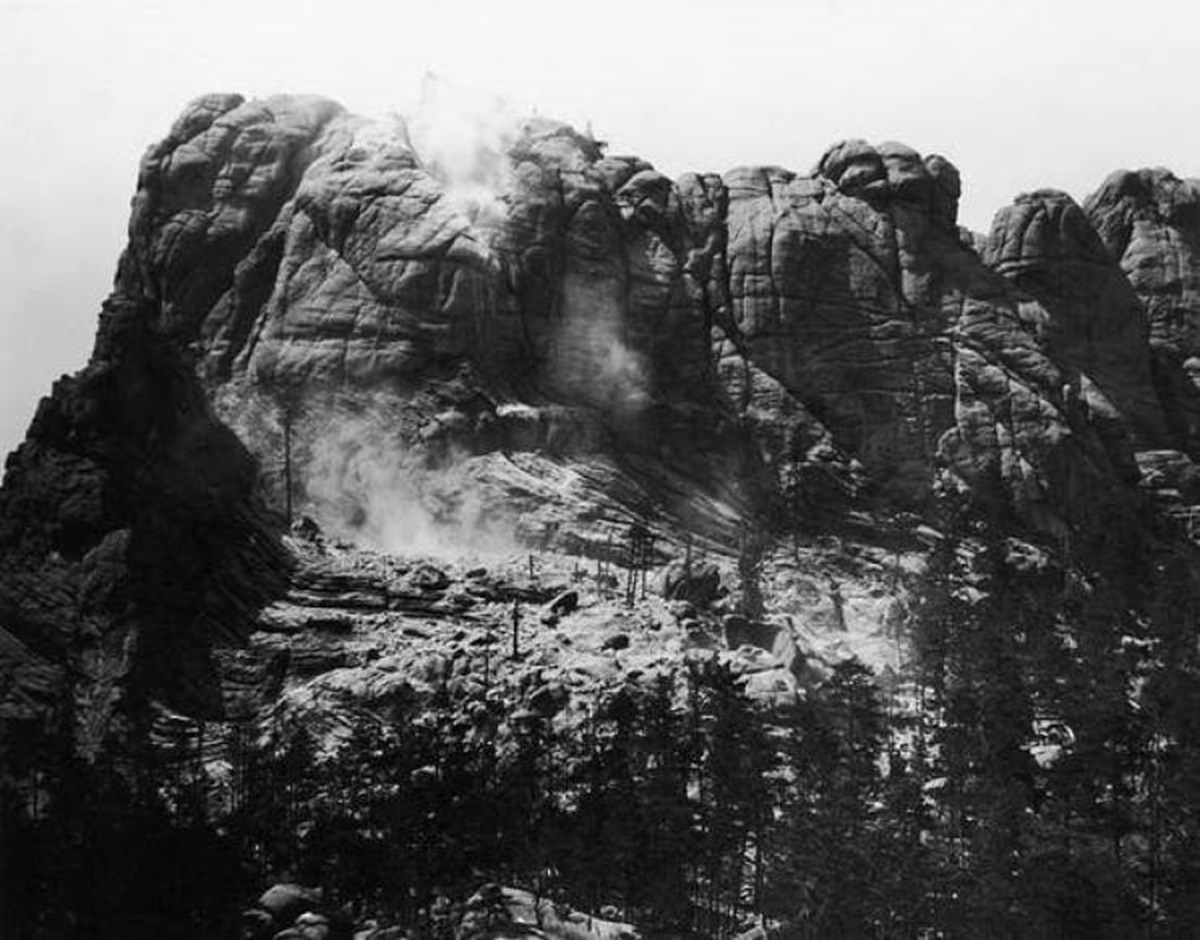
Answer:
131, 96, 704, 422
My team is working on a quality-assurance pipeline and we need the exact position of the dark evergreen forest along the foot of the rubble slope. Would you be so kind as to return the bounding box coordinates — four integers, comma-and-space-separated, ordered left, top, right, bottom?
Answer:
0, 513, 1200, 939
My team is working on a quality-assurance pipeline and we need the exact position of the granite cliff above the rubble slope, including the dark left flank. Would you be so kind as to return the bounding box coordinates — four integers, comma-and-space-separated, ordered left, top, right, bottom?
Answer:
0, 95, 1200, 738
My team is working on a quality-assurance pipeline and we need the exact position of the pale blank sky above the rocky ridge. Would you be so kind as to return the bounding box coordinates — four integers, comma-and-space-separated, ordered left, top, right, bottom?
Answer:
0, 0, 1200, 455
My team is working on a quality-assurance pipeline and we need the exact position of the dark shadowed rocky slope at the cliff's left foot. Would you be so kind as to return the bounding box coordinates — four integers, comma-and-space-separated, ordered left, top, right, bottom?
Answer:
0, 298, 289, 754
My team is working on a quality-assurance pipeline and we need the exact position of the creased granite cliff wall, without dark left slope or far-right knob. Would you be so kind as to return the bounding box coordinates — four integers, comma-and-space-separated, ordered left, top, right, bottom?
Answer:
117, 97, 1185, 525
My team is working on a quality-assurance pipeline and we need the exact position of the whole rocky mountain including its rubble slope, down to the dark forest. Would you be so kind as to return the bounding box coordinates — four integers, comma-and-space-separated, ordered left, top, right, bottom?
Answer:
0, 95, 1200, 931
